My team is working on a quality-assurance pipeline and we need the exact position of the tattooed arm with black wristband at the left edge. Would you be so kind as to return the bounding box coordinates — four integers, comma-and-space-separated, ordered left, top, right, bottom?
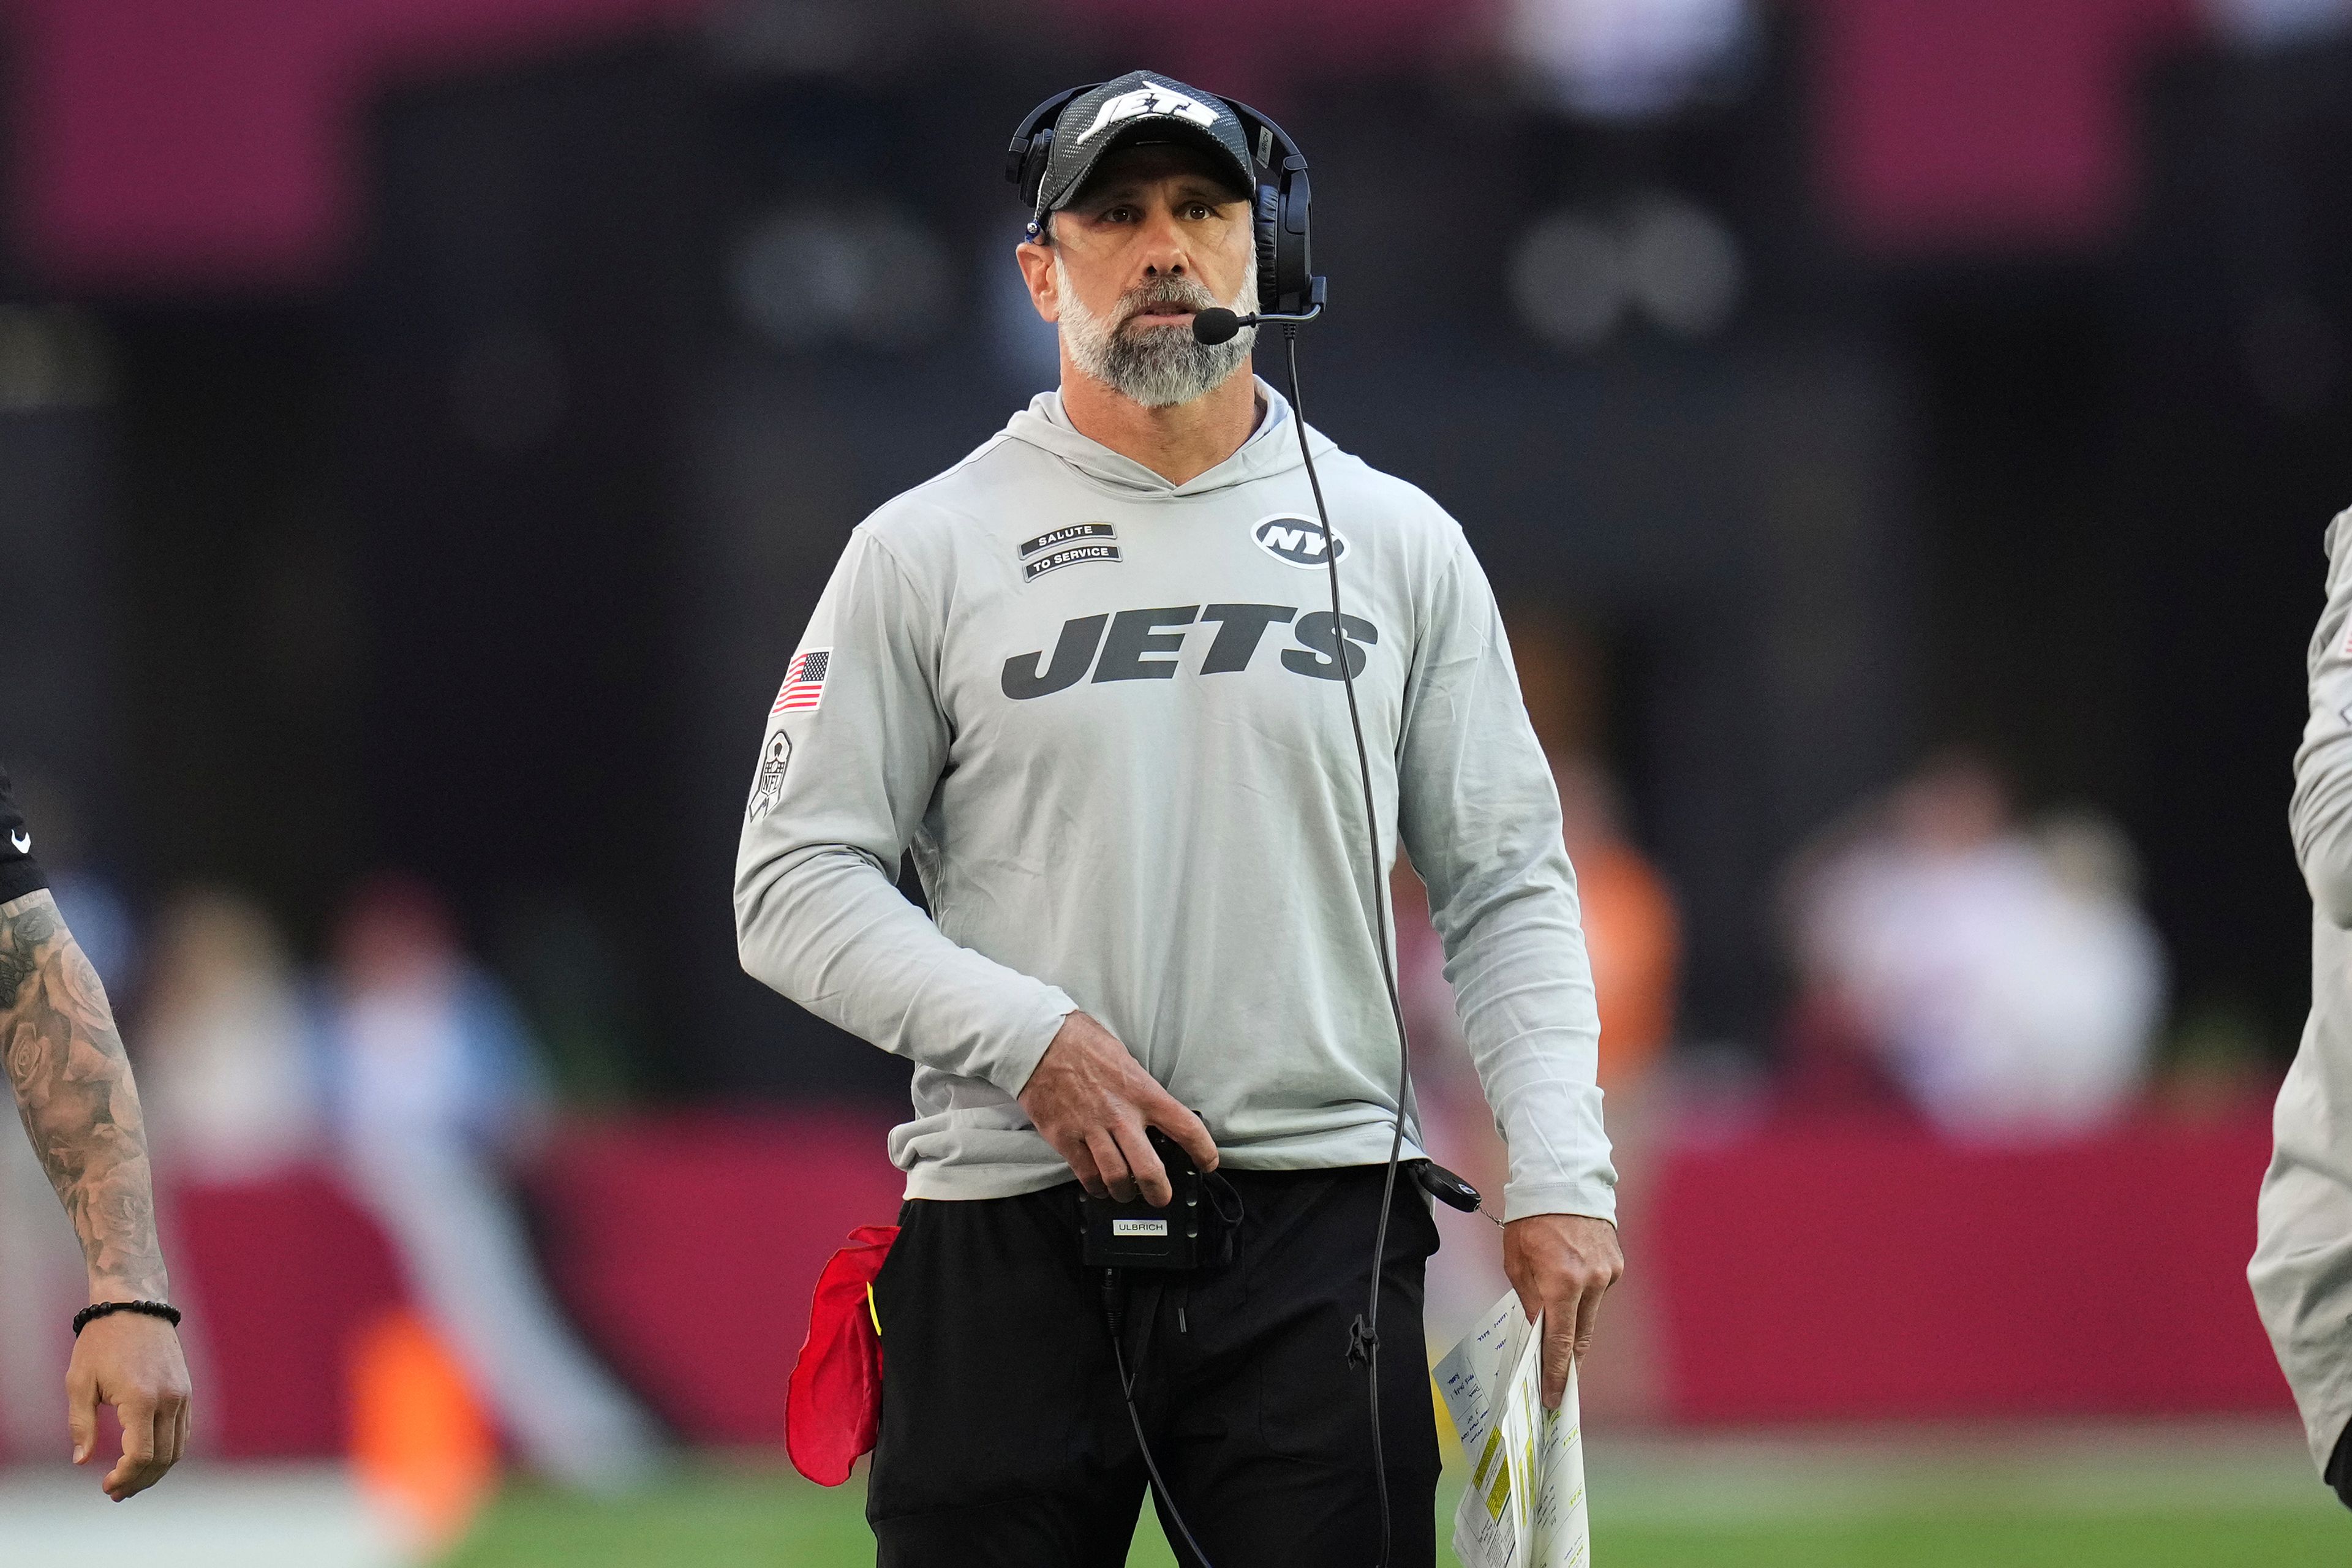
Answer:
0, 769, 188, 1502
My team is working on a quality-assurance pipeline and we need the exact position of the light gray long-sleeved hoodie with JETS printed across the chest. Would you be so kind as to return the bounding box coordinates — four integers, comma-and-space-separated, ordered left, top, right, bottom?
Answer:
734, 381, 1616, 1218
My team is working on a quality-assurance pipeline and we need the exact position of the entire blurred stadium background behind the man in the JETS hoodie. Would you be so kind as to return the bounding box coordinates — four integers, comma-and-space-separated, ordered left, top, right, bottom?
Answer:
0, 0, 2352, 1568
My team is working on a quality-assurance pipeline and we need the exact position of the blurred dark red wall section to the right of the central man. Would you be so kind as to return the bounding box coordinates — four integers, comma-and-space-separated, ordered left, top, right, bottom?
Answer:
1639, 1105, 2291, 1422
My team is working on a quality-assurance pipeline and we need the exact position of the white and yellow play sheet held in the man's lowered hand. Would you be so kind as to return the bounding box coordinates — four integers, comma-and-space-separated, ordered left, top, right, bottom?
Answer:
1437, 1291, 1593, 1568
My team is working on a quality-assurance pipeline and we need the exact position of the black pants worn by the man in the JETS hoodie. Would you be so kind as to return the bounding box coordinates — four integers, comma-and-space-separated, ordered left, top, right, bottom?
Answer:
865, 1166, 1437, 1568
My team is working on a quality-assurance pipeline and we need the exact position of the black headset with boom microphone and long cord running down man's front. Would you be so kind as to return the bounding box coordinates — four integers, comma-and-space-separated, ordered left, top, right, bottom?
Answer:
1005, 82, 1420, 1568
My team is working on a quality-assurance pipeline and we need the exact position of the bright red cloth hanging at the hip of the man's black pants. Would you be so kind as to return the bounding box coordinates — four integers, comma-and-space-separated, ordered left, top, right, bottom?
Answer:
783, 1225, 899, 1486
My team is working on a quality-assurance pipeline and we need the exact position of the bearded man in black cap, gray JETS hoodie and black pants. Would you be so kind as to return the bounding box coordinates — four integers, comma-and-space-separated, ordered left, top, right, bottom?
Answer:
736, 73, 1623, 1568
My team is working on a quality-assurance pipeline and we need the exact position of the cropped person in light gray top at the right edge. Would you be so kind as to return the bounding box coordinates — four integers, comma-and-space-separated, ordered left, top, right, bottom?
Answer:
2246, 513, 2352, 1507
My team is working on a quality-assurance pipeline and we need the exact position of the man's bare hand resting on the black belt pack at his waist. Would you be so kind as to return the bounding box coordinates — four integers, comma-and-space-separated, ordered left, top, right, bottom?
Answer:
1021, 1013, 1216, 1208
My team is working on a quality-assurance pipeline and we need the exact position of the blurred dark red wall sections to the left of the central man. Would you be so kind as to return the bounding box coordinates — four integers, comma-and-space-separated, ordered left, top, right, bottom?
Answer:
142, 1110, 905, 1458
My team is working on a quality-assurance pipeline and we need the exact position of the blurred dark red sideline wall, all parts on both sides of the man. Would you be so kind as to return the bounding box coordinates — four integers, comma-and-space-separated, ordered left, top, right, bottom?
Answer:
133, 1105, 2288, 1458
